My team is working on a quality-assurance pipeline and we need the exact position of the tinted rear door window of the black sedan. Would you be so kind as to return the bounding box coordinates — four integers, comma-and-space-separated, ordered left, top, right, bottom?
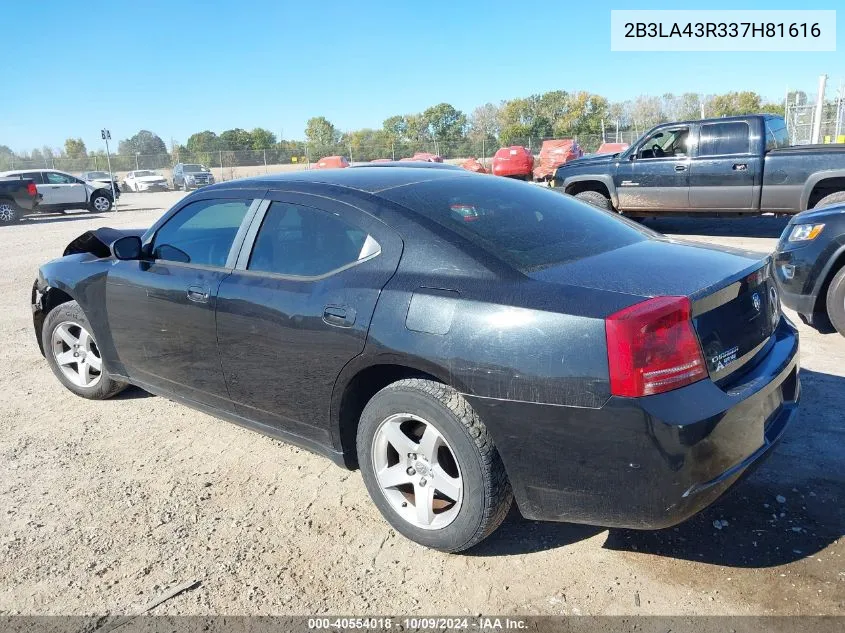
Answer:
247, 202, 378, 277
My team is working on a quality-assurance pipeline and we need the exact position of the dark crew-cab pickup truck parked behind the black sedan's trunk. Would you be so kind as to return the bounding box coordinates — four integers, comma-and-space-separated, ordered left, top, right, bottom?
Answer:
552, 114, 845, 217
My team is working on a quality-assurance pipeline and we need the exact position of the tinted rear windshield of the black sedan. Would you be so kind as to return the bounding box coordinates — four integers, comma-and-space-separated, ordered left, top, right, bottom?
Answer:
379, 176, 651, 273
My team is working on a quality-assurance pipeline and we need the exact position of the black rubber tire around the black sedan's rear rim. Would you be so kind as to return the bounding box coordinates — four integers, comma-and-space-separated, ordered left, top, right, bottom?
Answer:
357, 378, 513, 552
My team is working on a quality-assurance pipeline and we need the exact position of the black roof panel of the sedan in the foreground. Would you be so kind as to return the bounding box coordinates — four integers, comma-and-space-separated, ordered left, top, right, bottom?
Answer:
212, 164, 474, 193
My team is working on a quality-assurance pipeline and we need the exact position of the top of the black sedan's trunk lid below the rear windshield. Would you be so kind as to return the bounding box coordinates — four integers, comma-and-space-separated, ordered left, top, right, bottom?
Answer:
530, 237, 766, 299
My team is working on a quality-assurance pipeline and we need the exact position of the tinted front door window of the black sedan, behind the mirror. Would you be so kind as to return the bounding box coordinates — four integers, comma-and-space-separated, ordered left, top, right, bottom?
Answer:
152, 200, 252, 267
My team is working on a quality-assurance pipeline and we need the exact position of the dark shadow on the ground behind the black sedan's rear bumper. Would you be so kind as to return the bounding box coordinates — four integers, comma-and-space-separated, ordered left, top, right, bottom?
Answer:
467, 370, 845, 568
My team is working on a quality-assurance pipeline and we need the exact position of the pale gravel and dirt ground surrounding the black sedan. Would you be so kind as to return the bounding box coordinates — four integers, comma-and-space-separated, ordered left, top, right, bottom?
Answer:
0, 193, 845, 615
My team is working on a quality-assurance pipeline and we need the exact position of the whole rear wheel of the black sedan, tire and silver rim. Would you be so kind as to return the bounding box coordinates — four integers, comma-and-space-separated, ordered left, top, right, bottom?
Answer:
357, 378, 513, 552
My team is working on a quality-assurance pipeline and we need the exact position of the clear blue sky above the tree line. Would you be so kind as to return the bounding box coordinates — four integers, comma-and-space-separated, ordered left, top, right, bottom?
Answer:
0, 0, 845, 150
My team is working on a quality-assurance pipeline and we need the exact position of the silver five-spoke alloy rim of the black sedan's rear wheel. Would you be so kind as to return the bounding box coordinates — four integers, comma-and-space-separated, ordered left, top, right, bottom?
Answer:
372, 413, 464, 530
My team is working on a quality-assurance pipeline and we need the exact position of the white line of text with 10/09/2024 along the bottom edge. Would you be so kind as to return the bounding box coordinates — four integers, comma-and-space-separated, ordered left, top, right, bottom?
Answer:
308, 616, 528, 631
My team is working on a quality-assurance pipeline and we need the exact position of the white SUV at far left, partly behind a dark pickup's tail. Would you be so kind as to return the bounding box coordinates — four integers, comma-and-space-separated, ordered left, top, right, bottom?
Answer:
0, 169, 114, 213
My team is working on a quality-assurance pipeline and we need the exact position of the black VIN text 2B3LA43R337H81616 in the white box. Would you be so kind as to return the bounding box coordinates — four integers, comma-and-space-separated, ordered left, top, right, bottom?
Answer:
625, 22, 821, 38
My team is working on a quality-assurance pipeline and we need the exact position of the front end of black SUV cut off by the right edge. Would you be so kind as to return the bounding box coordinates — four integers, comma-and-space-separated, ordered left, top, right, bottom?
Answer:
775, 192, 845, 336
